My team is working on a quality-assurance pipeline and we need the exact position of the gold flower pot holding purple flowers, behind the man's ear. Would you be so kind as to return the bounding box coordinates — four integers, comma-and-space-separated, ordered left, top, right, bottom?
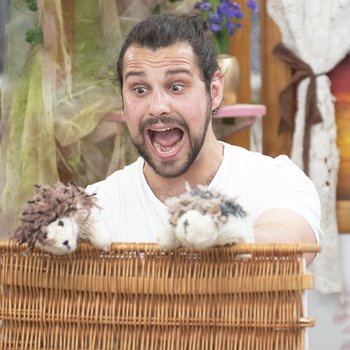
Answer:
218, 54, 241, 106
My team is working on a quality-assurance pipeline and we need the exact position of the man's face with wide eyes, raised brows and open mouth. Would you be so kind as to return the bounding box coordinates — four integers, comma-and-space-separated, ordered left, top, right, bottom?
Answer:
122, 43, 211, 177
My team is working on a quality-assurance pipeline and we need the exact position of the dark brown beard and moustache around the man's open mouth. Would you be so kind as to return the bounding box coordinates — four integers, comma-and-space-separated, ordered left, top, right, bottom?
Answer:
132, 101, 212, 178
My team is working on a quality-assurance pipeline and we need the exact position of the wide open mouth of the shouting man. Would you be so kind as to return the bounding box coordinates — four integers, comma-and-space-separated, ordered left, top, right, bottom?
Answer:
147, 127, 184, 157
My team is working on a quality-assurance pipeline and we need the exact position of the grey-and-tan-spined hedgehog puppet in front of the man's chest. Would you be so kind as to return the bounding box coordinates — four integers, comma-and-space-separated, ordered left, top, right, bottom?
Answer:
156, 184, 254, 249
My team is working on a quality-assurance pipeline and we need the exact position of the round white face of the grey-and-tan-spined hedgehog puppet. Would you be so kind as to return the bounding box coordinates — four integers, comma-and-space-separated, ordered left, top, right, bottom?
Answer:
175, 210, 218, 249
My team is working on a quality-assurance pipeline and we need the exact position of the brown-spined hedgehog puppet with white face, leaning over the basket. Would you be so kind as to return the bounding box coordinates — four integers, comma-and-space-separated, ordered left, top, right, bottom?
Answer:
12, 182, 112, 255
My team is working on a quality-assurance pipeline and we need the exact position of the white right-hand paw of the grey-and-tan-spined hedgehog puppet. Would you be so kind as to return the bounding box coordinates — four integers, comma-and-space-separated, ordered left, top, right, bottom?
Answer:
216, 216, 255, 245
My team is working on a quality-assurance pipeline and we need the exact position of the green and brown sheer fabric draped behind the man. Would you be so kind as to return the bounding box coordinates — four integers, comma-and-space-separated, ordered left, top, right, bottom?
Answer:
0, 0, 194, 237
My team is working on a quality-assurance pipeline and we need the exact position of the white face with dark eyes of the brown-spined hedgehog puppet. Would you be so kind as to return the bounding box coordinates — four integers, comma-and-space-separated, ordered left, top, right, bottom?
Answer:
35, 217, 79, 255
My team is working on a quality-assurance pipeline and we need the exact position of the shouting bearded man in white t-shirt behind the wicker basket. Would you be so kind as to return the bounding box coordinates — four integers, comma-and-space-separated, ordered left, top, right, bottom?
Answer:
88, 14, 320, 261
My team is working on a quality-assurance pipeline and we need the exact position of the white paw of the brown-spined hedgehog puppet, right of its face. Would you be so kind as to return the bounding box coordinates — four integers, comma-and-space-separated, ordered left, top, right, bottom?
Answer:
80, 208, 112, 251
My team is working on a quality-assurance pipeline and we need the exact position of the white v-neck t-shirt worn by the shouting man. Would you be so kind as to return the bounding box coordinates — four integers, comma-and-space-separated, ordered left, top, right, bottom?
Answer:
87, 143, 321, 242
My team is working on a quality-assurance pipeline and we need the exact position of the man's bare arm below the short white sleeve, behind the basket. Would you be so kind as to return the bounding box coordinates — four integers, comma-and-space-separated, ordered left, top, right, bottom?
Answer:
253, 208, 317, 264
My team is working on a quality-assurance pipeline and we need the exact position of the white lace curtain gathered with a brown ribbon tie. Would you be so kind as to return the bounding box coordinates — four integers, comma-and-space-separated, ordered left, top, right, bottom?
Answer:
267, 0, 350, 293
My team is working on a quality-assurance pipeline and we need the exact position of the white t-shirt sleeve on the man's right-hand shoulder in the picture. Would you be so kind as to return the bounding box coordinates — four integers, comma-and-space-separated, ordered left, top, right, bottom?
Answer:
257, 155, 322, 242
